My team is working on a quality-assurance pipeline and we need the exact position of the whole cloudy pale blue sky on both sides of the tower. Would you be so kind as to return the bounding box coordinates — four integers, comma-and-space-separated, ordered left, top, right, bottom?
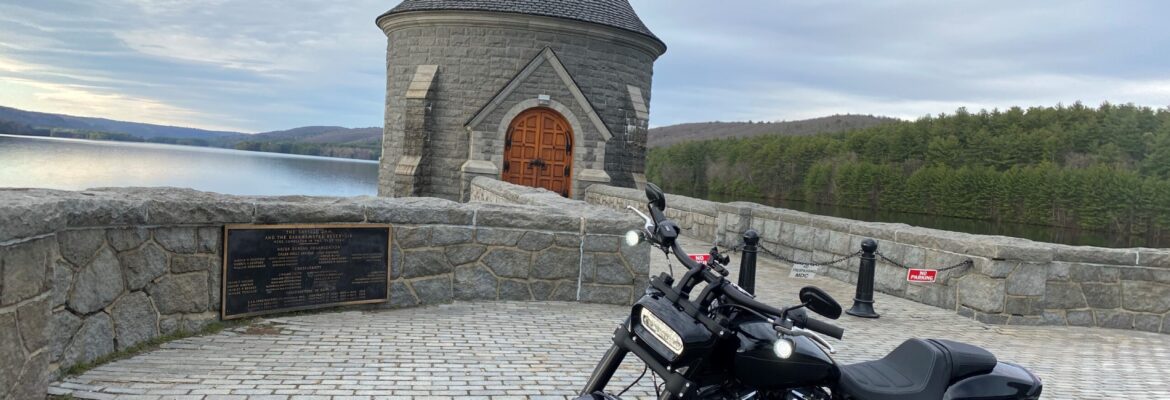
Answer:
0, 0, 1170, 132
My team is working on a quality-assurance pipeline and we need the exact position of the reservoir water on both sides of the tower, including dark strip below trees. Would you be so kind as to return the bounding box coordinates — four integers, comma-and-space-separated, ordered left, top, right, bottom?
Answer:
0, 135, 1170, 247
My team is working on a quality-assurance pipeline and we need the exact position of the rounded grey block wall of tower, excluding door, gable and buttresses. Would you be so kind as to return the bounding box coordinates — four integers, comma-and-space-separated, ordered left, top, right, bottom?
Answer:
379, 12, 658, 200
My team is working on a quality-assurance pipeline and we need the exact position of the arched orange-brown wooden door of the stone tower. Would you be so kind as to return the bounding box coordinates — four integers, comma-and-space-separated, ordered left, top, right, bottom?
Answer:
503, 108, 573, 198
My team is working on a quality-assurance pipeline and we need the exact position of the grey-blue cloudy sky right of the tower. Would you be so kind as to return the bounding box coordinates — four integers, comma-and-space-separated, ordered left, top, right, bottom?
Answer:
634, 0, 1170, 126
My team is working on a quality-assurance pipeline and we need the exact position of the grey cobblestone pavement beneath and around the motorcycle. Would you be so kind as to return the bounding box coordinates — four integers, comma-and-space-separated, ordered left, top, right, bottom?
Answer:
50, 237, 1170, 400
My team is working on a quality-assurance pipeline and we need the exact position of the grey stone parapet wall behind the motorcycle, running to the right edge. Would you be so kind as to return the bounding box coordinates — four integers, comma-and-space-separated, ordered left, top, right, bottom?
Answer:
585, 186, 1170, 333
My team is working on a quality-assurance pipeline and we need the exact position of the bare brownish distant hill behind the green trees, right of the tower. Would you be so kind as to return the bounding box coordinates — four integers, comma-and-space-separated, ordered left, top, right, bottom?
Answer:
647, 115, 900, 147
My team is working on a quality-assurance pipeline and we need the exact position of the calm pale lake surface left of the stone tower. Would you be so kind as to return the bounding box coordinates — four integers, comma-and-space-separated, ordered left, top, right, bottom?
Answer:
0, 135, 378, 196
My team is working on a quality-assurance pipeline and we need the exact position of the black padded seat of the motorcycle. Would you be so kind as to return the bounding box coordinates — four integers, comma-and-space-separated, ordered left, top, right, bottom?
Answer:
839, 339, 998, 400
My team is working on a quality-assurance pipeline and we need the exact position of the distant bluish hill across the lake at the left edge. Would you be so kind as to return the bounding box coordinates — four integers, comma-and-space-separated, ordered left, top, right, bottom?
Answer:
0, 106, 245, 139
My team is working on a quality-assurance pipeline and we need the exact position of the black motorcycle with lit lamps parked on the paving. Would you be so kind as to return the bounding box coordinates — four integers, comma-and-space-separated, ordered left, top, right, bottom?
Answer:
578, 184, 1041, 400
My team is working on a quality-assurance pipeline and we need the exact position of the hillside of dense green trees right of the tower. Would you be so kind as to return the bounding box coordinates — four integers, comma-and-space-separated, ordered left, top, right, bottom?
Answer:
647, 103, 1170, 235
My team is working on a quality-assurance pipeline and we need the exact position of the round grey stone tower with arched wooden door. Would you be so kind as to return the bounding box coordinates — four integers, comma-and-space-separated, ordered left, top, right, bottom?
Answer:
377, 0, 666, 201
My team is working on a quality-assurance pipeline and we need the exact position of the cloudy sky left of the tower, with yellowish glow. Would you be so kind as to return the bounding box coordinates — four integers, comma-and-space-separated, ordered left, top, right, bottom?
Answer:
0, 0, 388, 131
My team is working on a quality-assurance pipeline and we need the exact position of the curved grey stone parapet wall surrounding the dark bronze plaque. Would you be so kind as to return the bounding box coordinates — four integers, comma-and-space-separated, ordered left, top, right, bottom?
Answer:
0, 188, 649, 399
